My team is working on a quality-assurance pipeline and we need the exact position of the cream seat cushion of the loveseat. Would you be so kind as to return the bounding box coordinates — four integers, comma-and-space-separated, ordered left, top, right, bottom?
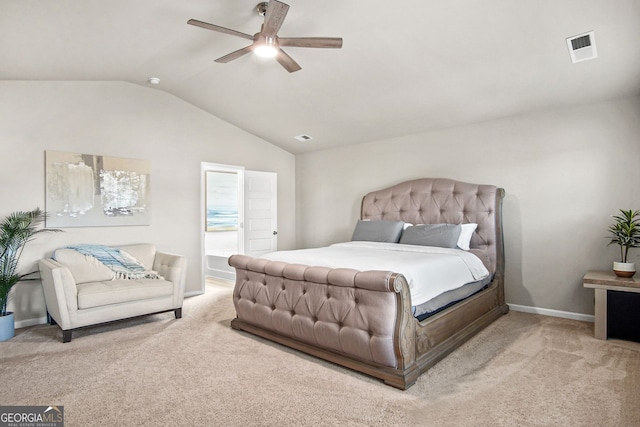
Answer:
77, 279, 173, 310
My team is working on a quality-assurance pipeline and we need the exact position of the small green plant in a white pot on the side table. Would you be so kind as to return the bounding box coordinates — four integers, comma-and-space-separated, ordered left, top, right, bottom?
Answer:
609, 209, 640, 277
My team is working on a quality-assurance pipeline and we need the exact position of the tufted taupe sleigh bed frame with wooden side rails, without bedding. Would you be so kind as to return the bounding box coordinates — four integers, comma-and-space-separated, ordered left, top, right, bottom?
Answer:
229, 178, 508, 389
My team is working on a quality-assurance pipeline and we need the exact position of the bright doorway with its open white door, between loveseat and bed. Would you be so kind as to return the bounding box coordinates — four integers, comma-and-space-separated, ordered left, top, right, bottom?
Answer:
201, 163, 278, 290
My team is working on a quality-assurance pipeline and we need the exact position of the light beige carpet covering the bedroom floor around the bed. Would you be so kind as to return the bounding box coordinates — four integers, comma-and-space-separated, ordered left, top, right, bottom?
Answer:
0, 287, 640, 427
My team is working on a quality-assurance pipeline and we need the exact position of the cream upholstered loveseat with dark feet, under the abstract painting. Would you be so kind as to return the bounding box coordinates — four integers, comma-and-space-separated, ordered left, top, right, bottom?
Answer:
39, 243, 187, 342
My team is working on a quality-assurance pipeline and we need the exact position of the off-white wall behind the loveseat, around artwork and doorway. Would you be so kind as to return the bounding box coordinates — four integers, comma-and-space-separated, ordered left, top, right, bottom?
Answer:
0, 81, 295, 326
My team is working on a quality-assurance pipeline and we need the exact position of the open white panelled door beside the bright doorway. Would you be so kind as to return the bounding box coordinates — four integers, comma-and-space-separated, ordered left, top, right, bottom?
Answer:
244, 170, 278, 257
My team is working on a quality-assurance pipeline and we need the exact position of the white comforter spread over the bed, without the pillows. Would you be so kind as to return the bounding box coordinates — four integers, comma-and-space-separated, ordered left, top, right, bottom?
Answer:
261, 242, 489, 306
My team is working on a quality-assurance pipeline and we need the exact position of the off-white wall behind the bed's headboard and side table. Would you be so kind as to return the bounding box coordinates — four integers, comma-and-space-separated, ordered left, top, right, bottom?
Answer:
296, 97, 640, 314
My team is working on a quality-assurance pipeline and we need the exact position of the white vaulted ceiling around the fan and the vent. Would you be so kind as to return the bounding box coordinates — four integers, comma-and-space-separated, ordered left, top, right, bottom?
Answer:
0, 0, 640, 153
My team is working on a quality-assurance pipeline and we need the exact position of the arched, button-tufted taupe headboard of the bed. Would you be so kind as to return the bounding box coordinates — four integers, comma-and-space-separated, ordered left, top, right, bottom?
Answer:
360, 178, 504, 275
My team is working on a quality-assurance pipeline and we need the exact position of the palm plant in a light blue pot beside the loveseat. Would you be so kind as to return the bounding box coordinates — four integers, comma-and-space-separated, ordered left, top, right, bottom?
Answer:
0, 208, 60, 341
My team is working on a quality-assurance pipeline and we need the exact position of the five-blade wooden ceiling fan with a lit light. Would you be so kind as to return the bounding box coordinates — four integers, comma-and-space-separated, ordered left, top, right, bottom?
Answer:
187, 0, 342, 73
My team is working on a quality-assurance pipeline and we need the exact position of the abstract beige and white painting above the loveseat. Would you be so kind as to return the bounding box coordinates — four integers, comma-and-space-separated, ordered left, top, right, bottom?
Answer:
45, 151, 151, 228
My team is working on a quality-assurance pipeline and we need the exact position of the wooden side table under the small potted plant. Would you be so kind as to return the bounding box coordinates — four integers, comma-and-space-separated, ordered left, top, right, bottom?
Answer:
582, 271, 640, 340
